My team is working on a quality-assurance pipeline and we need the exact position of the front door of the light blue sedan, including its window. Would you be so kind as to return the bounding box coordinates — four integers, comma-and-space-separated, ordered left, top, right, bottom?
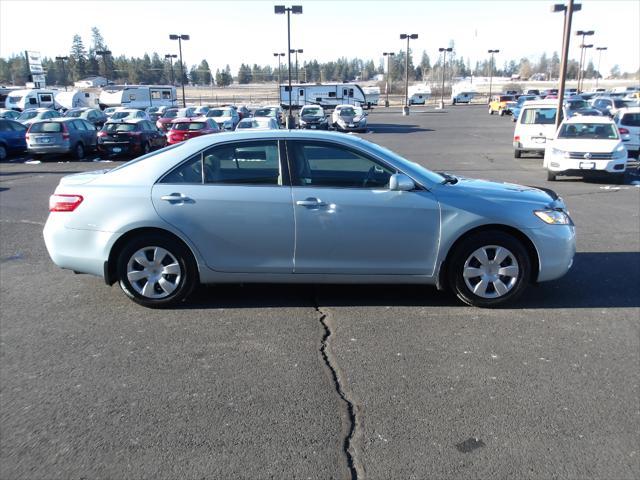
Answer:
287, 141, 440, 275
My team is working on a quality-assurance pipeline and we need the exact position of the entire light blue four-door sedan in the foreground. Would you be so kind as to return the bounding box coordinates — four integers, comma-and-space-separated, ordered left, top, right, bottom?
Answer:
44, 130, 575, 307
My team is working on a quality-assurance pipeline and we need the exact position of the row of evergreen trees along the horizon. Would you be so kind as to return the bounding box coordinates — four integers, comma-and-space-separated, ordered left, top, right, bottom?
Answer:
0, 27, 640, 87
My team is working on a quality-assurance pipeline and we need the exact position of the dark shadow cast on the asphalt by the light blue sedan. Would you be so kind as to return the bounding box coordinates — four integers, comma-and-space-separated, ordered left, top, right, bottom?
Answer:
177, 252, 640, 309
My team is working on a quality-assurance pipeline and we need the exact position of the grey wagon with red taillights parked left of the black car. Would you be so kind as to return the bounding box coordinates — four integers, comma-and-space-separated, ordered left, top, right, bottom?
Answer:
27, 117, 98, 160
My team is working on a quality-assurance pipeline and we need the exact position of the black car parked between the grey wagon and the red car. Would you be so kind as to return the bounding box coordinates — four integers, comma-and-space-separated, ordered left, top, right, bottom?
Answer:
98, 119, 167, 156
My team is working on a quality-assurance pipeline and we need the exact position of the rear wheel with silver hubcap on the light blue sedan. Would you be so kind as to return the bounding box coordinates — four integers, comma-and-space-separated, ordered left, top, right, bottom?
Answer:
117, 235, 197, 308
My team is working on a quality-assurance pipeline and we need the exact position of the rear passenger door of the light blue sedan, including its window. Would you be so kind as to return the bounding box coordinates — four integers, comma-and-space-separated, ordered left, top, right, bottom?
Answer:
152, 140, 294, 273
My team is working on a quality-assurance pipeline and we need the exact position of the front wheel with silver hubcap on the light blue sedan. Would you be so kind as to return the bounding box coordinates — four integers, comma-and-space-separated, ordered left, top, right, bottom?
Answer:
447, 231, 531, 308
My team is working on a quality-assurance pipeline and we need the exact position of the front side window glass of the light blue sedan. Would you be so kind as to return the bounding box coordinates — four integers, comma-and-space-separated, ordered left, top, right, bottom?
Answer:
291, 142, 396, 189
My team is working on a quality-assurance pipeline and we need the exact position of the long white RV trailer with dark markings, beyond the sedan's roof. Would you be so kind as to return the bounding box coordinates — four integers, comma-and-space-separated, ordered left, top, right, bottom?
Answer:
280, 83, 367, 108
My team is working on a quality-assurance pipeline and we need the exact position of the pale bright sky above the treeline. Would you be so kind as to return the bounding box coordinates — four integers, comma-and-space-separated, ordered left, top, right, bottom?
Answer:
0, 0, 640, 74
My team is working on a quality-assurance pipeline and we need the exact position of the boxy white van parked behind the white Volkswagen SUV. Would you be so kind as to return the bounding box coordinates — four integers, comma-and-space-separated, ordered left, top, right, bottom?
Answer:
513, 99, 562, 158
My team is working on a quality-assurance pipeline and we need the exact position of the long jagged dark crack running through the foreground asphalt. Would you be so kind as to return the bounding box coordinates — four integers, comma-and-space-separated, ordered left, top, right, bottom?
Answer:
315, 296, 364, 480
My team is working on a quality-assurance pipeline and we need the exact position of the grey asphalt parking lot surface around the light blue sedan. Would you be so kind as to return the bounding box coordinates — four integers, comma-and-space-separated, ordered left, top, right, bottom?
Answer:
0, 105, 640, 479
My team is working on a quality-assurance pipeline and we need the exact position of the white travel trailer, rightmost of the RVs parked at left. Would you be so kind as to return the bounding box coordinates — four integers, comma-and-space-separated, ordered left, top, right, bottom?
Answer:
99, 85, 177, 109
